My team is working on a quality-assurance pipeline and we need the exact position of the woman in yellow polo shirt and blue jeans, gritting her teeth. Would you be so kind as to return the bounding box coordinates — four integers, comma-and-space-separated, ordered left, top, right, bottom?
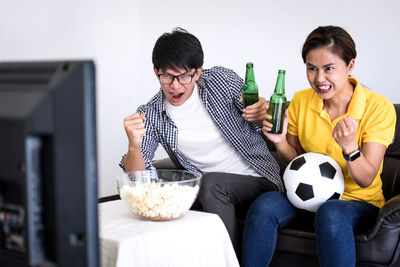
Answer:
243, 26, 396, 267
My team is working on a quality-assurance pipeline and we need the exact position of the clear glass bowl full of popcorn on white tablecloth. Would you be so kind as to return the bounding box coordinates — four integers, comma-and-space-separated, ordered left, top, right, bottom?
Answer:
117, 170, 202, 221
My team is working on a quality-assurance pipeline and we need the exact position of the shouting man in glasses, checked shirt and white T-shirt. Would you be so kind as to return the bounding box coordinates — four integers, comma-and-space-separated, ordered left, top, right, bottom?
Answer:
120, 28, 283, 258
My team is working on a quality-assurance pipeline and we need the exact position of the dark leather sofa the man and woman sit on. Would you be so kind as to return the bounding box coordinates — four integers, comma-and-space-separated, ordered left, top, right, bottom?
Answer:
144, 104, 400, 267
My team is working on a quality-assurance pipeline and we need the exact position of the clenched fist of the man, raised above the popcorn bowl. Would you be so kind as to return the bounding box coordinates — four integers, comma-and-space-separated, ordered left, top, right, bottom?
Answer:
124, 113, 146, 151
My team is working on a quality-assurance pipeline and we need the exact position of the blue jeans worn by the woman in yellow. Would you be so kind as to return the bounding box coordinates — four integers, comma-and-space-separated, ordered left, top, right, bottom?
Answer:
243, 192, 379, 267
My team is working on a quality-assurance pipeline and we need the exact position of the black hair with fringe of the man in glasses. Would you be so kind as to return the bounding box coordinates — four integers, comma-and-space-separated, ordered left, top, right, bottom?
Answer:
152, 28, 204, 71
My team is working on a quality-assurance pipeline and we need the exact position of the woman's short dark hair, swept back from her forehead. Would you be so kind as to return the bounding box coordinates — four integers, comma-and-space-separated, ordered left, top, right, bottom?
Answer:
301, 26, 357, 65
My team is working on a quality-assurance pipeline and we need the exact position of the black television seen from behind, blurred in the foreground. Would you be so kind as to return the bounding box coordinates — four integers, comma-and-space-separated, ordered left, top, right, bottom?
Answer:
0, 60, 99, 267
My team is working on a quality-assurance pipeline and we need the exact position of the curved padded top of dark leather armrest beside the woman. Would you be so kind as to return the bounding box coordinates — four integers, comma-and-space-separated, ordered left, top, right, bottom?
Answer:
356, 195, 400, 241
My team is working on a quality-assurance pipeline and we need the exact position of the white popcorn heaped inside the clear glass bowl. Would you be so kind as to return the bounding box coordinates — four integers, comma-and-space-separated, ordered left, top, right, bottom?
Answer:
119, 183, 199, 220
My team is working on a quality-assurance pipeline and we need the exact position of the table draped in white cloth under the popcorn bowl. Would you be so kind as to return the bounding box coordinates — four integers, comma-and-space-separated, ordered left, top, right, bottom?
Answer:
99, 200, 239, 267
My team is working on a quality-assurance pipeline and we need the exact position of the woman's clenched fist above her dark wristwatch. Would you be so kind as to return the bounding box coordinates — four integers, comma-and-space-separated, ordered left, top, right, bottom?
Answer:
332, 116, 358, 155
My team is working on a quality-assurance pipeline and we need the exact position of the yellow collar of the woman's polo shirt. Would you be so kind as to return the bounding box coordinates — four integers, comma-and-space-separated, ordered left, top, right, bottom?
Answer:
310, 77, 366, 119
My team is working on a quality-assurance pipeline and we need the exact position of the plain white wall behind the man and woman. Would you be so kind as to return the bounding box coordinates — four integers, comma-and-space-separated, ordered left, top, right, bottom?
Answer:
0, 0, 400, 196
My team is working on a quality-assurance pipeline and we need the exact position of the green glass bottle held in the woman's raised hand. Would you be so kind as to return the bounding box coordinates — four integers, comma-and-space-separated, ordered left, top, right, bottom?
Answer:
268, 70, 286, 134
